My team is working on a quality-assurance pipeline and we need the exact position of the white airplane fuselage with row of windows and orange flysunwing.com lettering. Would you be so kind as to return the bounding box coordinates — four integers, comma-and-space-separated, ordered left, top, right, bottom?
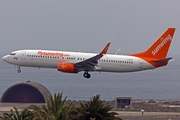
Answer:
3, 50, 155, 72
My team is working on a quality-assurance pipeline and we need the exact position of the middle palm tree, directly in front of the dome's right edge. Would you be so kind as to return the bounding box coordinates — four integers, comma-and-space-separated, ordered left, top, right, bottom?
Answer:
30, 93, 73, 120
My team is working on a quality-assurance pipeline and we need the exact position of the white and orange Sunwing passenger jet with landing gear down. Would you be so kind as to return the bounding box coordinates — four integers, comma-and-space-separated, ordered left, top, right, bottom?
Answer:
2, 28, 175, 78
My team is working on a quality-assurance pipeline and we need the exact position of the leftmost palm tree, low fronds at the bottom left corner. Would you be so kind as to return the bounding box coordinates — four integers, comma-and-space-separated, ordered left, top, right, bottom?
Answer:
0, 107, 33, 120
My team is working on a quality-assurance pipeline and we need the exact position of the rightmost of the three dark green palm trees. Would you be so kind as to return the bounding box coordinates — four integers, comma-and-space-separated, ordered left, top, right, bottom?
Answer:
70, 95, 121, 120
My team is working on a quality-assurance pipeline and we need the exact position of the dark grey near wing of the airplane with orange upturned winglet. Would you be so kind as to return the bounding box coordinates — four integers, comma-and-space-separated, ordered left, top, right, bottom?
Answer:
74, 42, 110, 71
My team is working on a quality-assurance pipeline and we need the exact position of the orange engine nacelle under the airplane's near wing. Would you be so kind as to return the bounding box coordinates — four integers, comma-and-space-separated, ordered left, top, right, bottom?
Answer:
57, 62, 78, 73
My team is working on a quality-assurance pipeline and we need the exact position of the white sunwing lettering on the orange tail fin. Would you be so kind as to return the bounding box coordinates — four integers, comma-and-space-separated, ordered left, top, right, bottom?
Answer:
152, 35, 172, 55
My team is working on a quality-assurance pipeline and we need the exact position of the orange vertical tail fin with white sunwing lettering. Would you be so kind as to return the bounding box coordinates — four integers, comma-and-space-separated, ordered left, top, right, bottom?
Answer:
131, 28, 175, 59
